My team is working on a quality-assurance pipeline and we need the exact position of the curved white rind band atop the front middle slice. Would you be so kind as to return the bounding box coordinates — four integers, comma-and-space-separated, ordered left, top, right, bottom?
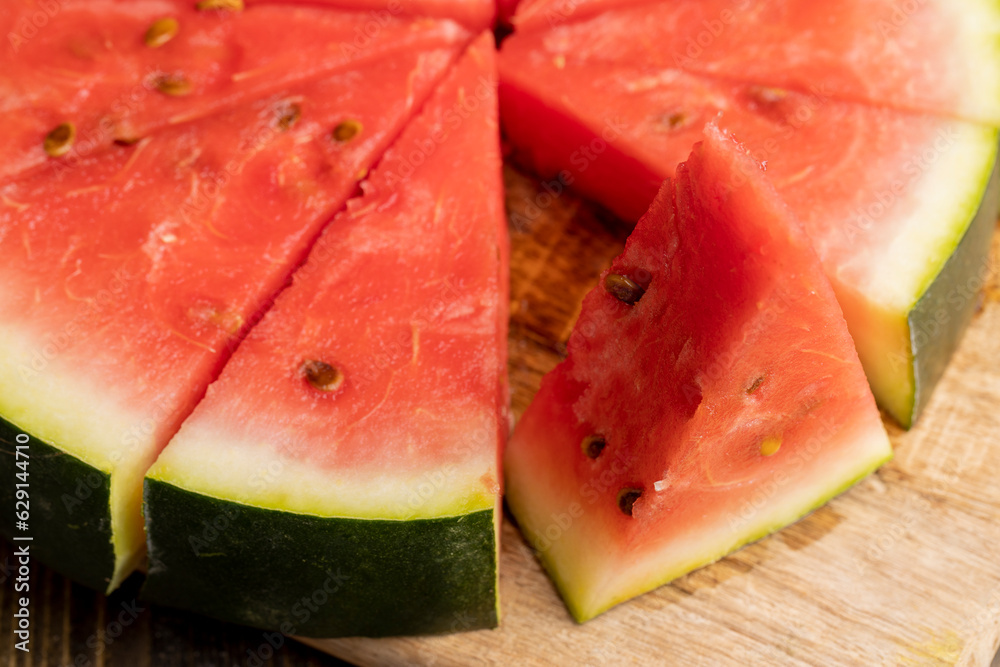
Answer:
147, 410, 499, 520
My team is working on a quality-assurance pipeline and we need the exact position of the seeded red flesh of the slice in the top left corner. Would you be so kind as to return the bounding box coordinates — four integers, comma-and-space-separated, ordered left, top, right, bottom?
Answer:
0, 0, 470, 178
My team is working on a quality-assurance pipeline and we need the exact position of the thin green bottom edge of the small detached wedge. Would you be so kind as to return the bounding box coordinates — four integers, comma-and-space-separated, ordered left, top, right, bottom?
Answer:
506, 433, 893, 623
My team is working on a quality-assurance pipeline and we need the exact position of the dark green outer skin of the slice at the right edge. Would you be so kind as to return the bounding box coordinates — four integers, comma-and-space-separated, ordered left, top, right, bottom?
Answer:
912, 147, 1000, 428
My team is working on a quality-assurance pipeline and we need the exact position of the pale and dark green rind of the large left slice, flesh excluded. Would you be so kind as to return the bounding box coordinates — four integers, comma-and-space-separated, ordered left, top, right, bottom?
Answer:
0, 298, 188, 593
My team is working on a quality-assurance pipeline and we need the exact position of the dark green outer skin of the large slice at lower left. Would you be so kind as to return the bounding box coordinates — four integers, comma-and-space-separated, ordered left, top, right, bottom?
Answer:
0, 419, 115, 591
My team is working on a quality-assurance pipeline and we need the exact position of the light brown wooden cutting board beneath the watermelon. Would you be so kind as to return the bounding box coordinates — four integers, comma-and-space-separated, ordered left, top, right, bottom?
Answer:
304, 168, 1000, 667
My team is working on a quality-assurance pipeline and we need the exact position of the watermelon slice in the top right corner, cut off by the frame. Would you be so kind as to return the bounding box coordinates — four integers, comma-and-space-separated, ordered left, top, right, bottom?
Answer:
504, 0, 1000, 125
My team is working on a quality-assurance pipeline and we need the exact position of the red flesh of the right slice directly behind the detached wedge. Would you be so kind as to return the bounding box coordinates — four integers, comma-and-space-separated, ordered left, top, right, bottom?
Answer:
501, 47, 991, 297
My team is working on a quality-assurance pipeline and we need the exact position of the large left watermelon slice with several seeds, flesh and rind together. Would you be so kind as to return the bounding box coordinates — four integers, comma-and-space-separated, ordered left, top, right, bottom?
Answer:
0, 43, 457, 589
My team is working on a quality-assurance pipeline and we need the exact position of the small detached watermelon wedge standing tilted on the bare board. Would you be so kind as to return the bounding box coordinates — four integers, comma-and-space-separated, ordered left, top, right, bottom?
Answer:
504, 126, 892, 621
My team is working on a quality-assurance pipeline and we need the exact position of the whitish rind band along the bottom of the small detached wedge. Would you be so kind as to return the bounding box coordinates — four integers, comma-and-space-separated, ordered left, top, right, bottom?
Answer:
507, 420, 892, 622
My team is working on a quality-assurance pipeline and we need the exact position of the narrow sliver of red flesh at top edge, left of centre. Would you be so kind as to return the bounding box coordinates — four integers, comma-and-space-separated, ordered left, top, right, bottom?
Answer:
247, 0, 497, 34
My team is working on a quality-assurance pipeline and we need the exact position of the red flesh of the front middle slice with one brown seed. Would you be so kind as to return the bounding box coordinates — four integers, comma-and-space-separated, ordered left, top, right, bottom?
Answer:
146, 26, 506, 544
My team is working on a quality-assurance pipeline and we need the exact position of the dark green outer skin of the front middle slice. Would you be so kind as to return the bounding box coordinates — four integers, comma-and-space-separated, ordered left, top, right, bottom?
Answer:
144, 478, 498, 637
